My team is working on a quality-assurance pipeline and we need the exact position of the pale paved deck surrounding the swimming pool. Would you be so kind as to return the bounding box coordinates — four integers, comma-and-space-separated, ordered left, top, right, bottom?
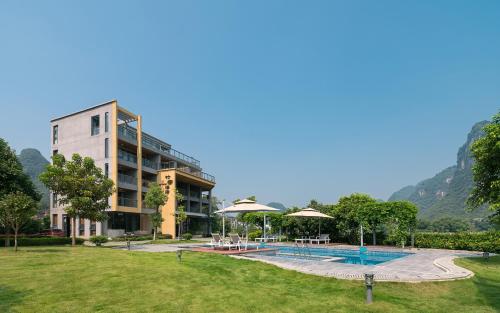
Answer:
118, 243, 482, 283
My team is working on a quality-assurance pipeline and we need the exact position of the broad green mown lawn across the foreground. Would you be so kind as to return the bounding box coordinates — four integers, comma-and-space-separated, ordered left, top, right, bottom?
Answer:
0, 247, 500, 313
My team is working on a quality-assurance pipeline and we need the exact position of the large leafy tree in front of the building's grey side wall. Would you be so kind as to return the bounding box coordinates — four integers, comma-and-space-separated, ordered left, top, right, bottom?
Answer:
39, 153, 115, 246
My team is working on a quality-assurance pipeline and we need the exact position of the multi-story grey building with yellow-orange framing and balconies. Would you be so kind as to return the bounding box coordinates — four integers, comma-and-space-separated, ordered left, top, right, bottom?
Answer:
51, 100, 215, 237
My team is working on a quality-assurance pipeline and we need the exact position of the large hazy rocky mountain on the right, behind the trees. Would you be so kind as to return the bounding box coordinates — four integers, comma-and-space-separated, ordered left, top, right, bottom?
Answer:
389, 121, 488, 220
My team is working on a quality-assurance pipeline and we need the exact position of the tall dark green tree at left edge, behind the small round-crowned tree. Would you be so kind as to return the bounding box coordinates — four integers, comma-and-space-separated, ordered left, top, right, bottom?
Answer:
0, 138, 41, 246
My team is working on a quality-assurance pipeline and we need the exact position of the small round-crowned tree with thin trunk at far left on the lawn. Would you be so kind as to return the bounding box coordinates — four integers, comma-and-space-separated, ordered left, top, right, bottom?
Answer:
0, 191, 37, 251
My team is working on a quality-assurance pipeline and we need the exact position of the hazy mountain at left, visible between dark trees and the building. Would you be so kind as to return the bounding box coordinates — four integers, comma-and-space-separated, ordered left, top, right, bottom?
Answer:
17, 148, 49, 213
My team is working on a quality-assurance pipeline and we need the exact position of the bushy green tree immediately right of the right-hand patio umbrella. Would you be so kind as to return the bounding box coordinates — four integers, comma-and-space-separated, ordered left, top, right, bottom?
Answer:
331, 193, 376, 243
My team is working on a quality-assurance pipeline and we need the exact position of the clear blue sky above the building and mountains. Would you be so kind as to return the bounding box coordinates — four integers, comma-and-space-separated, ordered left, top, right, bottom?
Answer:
0, 1, 500, 206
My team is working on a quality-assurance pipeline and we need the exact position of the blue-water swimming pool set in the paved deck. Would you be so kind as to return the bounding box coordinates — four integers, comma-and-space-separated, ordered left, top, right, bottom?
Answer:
247, 245, 411, 265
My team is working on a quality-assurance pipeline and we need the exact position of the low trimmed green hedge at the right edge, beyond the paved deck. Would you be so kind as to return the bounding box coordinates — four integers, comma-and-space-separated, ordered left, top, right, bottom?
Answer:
415, 231, 500, 253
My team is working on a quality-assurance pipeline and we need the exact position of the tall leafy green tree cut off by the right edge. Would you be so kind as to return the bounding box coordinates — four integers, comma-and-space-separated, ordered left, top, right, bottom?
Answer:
467, 113, 500, 224
